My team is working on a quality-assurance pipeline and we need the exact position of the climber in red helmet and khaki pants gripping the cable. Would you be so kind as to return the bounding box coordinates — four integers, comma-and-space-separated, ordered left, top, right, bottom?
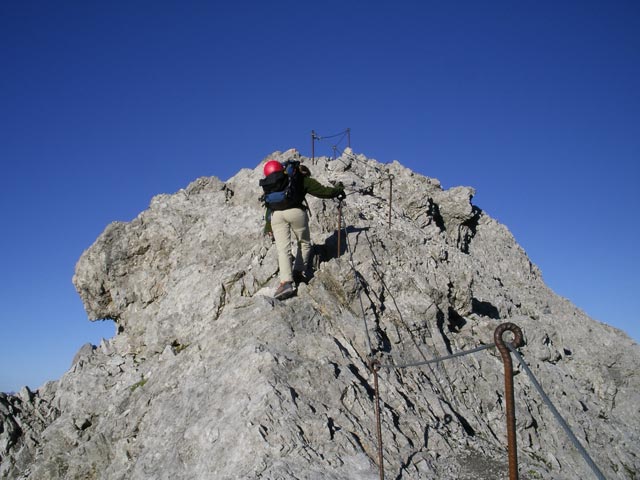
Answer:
260, 160, 345, 300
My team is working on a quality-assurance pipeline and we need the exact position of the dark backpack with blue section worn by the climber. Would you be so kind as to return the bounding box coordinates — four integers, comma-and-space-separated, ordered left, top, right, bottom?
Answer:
260, 160, 304, 210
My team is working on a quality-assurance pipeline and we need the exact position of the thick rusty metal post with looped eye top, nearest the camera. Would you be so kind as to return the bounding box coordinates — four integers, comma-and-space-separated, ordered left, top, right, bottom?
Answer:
493, 322, 523, 480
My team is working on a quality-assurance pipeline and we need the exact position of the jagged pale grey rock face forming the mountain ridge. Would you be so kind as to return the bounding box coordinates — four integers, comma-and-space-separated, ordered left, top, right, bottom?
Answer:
0, 150, 640, 480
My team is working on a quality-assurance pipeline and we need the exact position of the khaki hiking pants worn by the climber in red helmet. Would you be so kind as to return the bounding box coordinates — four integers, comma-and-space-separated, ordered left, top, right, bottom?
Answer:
271, 208, 311, 282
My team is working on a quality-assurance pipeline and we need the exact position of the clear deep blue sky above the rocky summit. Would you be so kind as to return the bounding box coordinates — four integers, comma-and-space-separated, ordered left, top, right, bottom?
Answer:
0, 0, 640, 391
